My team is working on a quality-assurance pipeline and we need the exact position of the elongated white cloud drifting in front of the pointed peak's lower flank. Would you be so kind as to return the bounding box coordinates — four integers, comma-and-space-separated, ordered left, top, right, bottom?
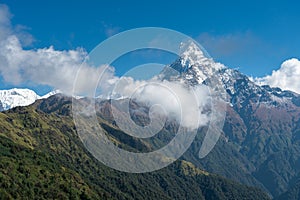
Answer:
108, 77, 210, 128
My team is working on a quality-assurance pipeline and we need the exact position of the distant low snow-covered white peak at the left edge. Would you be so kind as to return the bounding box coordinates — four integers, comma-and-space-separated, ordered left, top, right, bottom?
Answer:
0, 88, 60, 111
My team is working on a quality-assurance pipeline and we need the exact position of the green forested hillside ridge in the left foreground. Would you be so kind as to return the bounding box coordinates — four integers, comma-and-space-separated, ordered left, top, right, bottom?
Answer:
0, 96, 269, 199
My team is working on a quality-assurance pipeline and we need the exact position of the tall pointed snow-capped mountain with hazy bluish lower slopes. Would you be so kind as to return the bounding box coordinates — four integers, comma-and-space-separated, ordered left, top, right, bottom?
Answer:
162, 43, 300, 196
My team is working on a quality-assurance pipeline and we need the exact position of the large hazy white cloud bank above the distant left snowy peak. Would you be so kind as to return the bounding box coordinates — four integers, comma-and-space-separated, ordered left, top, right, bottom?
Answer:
0, 5, 108, 94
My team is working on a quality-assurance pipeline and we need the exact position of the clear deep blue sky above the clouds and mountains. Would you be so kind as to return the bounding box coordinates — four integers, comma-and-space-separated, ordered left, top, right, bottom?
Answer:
0, 0, 300, 93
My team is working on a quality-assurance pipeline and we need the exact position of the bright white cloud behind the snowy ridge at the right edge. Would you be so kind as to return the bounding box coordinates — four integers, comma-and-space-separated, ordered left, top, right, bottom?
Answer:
254, 58, 300, 94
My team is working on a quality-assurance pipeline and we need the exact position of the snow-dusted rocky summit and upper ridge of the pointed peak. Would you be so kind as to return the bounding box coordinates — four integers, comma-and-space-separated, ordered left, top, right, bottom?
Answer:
164, 42, 300, 107
